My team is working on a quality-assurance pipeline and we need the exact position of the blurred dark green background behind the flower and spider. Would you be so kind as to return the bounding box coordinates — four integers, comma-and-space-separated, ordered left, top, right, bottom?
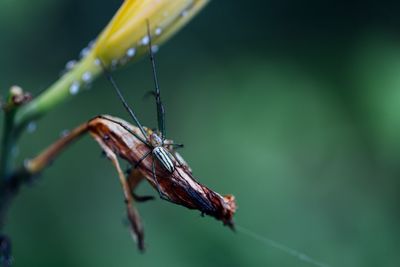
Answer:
0, 0, 400, 266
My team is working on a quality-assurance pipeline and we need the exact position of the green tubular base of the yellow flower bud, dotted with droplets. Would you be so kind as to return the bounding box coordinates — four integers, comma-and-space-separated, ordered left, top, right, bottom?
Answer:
14, 53, 102, 130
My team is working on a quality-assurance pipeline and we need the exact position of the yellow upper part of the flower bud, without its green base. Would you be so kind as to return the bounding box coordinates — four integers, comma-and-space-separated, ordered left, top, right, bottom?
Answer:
93, 0, 209, 67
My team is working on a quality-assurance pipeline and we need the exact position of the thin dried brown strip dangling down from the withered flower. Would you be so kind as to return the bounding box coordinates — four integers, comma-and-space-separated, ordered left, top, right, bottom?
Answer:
93, 135, 144, 251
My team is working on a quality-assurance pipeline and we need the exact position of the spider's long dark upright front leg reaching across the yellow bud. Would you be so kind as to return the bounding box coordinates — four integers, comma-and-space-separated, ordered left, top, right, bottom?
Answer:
146, 20, 165, 142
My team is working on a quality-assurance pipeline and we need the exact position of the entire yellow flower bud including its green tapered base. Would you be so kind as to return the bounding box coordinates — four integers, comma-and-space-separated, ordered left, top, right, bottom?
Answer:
15, 0, 209, 128
